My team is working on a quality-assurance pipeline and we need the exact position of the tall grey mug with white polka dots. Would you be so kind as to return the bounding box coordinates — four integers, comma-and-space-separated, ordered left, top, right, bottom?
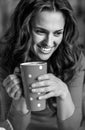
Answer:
20, 62, 47, 111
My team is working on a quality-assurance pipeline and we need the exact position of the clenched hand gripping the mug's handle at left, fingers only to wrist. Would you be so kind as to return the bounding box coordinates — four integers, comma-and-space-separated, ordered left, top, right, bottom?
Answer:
3, 74, 22, 100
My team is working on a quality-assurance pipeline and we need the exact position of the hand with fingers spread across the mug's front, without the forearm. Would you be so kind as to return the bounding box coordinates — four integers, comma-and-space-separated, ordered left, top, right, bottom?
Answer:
30, 74, 68, 99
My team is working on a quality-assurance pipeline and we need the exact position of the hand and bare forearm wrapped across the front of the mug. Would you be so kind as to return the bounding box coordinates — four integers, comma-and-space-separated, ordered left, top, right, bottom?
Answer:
30, 74, 75, 120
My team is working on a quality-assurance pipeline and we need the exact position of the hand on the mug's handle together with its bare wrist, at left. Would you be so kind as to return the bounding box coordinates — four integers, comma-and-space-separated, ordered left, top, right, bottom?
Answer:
3, 74, 29, 114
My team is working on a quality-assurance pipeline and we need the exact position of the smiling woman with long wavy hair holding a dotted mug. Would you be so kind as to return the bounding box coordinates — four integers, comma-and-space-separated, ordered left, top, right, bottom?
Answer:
0, 0, 85, 130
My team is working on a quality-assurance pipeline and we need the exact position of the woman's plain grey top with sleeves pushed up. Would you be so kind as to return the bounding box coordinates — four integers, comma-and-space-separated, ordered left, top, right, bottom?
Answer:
0, 53, 85, 130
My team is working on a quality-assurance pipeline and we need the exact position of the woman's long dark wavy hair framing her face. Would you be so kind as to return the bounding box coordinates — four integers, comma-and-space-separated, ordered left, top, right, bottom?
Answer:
0, 0, 79, 79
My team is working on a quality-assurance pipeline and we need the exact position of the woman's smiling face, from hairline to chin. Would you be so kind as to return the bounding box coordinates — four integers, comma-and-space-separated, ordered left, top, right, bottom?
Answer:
32, 11, 65, 61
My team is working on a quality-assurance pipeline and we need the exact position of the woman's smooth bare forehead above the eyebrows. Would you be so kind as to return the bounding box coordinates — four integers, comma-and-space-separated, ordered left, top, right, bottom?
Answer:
33, 11, 65, 29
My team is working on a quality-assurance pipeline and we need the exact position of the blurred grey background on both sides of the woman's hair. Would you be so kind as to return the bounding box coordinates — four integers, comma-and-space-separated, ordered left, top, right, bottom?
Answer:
0, 0, 85, 52
